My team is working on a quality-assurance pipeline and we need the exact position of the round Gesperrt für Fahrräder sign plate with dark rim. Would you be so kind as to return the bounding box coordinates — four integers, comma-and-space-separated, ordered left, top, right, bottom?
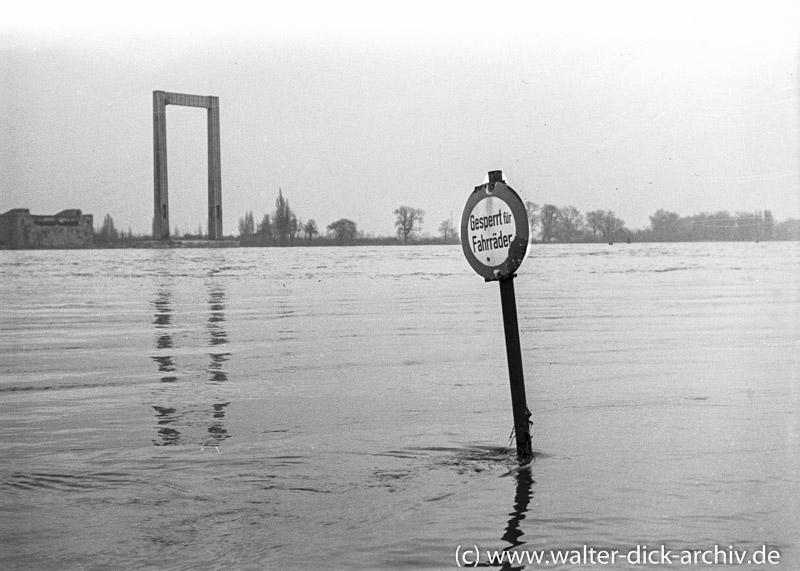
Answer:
461, 182, 528, 281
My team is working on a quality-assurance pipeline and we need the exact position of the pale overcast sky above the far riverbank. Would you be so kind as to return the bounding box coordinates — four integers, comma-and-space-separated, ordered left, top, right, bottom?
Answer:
0, 1, 800, 235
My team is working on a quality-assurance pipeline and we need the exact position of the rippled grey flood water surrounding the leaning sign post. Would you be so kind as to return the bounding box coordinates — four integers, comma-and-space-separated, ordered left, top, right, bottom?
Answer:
0, 243, 800, 570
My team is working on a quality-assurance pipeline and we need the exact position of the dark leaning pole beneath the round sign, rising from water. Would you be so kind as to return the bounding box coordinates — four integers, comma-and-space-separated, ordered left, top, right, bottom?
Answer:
500, 275, 533, 462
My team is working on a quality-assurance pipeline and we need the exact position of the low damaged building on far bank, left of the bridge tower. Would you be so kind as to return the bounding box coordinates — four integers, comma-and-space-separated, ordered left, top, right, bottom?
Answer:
0, 208, 94, 249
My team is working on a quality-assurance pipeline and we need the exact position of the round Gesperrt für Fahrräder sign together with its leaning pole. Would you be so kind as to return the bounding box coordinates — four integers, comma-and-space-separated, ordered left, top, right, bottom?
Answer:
461, 171, 533, 462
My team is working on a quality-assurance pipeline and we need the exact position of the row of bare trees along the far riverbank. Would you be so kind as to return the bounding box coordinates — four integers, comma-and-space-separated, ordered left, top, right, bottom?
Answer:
95, 192, 800, 246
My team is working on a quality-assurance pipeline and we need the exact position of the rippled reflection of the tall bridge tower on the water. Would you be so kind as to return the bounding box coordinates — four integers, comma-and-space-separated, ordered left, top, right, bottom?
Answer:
151, 282, 231, 446
